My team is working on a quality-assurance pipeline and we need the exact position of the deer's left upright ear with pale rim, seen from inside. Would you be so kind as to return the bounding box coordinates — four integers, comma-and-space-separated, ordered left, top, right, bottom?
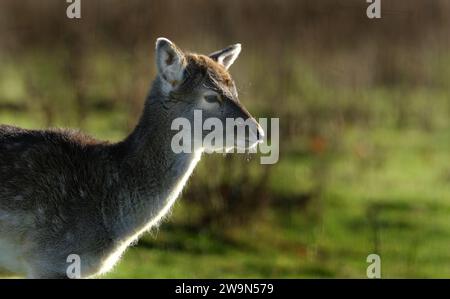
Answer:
156, 37, 186, 89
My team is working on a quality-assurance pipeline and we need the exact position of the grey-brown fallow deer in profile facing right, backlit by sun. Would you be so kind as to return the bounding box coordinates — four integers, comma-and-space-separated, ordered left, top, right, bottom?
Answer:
0, 38, 263, 278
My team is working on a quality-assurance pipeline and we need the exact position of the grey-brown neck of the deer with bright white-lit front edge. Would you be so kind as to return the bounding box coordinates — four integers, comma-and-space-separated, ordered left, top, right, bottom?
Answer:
107, 83, 202, 240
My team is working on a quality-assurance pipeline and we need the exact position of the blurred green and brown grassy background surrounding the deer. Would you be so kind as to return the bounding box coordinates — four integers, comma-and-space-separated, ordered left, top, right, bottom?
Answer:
0, 0, 450, 278
